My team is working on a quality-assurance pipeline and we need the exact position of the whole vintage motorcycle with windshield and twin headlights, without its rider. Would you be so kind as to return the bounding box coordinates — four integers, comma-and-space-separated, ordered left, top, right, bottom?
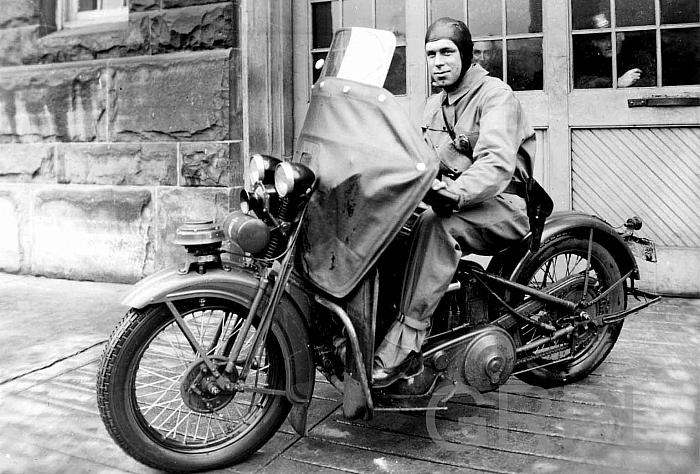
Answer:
97, 28, 658, 471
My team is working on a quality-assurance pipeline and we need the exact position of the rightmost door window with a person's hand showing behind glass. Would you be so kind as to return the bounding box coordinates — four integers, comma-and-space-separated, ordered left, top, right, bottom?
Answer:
571, 0, 700, 89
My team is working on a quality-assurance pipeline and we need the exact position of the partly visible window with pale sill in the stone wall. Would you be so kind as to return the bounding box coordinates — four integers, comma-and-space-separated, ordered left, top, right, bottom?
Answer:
56, 0, 129, 29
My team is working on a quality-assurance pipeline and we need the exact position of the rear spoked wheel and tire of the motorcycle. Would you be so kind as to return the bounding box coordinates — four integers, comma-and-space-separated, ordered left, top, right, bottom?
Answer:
514, 234, 626, 387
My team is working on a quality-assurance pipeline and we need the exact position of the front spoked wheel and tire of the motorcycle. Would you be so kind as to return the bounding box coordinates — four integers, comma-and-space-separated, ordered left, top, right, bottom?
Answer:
97, 298, 291, 472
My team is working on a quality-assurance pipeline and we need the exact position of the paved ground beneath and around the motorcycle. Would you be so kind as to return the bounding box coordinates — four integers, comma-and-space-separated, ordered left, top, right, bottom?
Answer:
0, 275, 700, 473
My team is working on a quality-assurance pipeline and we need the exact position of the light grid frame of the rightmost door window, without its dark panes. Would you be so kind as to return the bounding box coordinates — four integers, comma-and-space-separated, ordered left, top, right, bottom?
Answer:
567, 0, 700, 91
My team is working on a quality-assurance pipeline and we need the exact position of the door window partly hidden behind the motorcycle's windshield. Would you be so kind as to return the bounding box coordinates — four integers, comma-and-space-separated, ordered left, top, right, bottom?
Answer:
309, 0, 406, 95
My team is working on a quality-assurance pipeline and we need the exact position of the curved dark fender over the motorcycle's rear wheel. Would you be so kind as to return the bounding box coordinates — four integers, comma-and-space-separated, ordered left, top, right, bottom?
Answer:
488, 211, 639, 280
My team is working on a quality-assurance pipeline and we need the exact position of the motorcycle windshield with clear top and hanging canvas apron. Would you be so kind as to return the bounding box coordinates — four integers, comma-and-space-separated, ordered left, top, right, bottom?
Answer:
293, 28, 438, 297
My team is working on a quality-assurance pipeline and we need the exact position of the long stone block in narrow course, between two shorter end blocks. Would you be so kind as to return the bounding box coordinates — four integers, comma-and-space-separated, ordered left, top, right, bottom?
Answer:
56, 143, 177, 186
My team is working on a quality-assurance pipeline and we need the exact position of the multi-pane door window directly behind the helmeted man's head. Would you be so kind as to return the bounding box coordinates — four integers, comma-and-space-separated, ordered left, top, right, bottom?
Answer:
430, 0, 543, 90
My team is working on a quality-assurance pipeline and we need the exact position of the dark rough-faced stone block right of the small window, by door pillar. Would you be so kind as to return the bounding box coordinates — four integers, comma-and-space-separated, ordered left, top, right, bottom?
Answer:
151, 3, 238, 54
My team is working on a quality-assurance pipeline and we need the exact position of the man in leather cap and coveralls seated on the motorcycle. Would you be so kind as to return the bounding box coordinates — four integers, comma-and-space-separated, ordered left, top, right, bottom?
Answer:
372, 18, 535, 388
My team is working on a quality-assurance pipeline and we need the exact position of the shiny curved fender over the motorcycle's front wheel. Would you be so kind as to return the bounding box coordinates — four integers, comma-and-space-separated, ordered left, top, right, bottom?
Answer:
122, 268, 315, 432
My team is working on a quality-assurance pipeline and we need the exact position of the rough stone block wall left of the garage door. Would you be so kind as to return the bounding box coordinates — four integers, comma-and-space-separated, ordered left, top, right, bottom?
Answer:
0, 0, 246, 282
